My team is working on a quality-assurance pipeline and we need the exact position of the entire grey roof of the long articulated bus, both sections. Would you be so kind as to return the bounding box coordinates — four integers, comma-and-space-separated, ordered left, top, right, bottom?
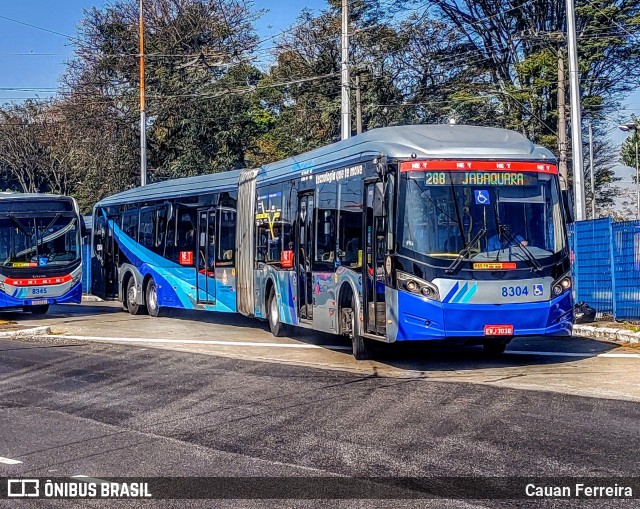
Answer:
97, 124, 555, 206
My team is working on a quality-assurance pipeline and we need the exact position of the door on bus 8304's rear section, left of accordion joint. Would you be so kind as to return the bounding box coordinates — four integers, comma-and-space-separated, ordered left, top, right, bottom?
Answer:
196, 208, 216, 304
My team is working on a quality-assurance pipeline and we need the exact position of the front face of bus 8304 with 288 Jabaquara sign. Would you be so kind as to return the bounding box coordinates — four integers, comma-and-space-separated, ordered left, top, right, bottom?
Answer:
387, 160, 573, 349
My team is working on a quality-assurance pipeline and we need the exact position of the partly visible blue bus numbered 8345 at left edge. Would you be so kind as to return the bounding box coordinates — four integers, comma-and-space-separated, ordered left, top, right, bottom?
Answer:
0, 192, 83, 314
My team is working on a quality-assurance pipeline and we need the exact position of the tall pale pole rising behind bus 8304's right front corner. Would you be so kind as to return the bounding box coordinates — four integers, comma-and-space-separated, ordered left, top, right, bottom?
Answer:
566, 0, 586, 221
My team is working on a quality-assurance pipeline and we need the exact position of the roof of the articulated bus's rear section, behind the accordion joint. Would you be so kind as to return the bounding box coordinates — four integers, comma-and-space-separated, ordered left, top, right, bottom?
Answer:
96, 170, 240, 207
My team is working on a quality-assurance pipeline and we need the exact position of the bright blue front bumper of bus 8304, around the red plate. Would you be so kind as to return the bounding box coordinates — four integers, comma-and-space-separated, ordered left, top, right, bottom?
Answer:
388, 292, 573, 341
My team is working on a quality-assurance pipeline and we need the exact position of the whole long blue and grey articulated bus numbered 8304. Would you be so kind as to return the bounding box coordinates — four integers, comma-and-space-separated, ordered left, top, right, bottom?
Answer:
92, 125, 573, 359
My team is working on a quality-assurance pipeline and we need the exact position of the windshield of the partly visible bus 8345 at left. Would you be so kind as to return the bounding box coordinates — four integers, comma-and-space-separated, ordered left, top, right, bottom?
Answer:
0, 214, 80, 268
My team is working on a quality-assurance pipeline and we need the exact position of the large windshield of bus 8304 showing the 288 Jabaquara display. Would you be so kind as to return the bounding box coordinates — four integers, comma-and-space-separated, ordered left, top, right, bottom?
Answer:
399, 170, 566, 266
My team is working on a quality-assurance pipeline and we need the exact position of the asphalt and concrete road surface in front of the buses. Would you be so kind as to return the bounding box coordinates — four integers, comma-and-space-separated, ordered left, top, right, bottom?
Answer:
0, 305, 640, 507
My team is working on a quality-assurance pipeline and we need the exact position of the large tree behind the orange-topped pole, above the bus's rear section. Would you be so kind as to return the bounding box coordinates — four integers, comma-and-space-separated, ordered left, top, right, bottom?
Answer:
63, 0, 260, 210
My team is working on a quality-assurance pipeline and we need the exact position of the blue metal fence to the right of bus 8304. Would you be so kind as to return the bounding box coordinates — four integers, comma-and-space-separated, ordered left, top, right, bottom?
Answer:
569, 218, 640, 320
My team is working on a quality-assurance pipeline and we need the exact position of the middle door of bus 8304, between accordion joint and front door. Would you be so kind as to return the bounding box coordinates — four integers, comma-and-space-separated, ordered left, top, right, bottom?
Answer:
294, 194, 313, 320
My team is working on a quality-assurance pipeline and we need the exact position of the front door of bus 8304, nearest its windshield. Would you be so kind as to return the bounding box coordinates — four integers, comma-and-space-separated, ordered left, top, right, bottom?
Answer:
363, 182, 386, 336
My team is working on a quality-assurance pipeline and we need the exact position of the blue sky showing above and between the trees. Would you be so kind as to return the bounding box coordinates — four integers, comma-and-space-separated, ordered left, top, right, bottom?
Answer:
0, 0, 640, 180
